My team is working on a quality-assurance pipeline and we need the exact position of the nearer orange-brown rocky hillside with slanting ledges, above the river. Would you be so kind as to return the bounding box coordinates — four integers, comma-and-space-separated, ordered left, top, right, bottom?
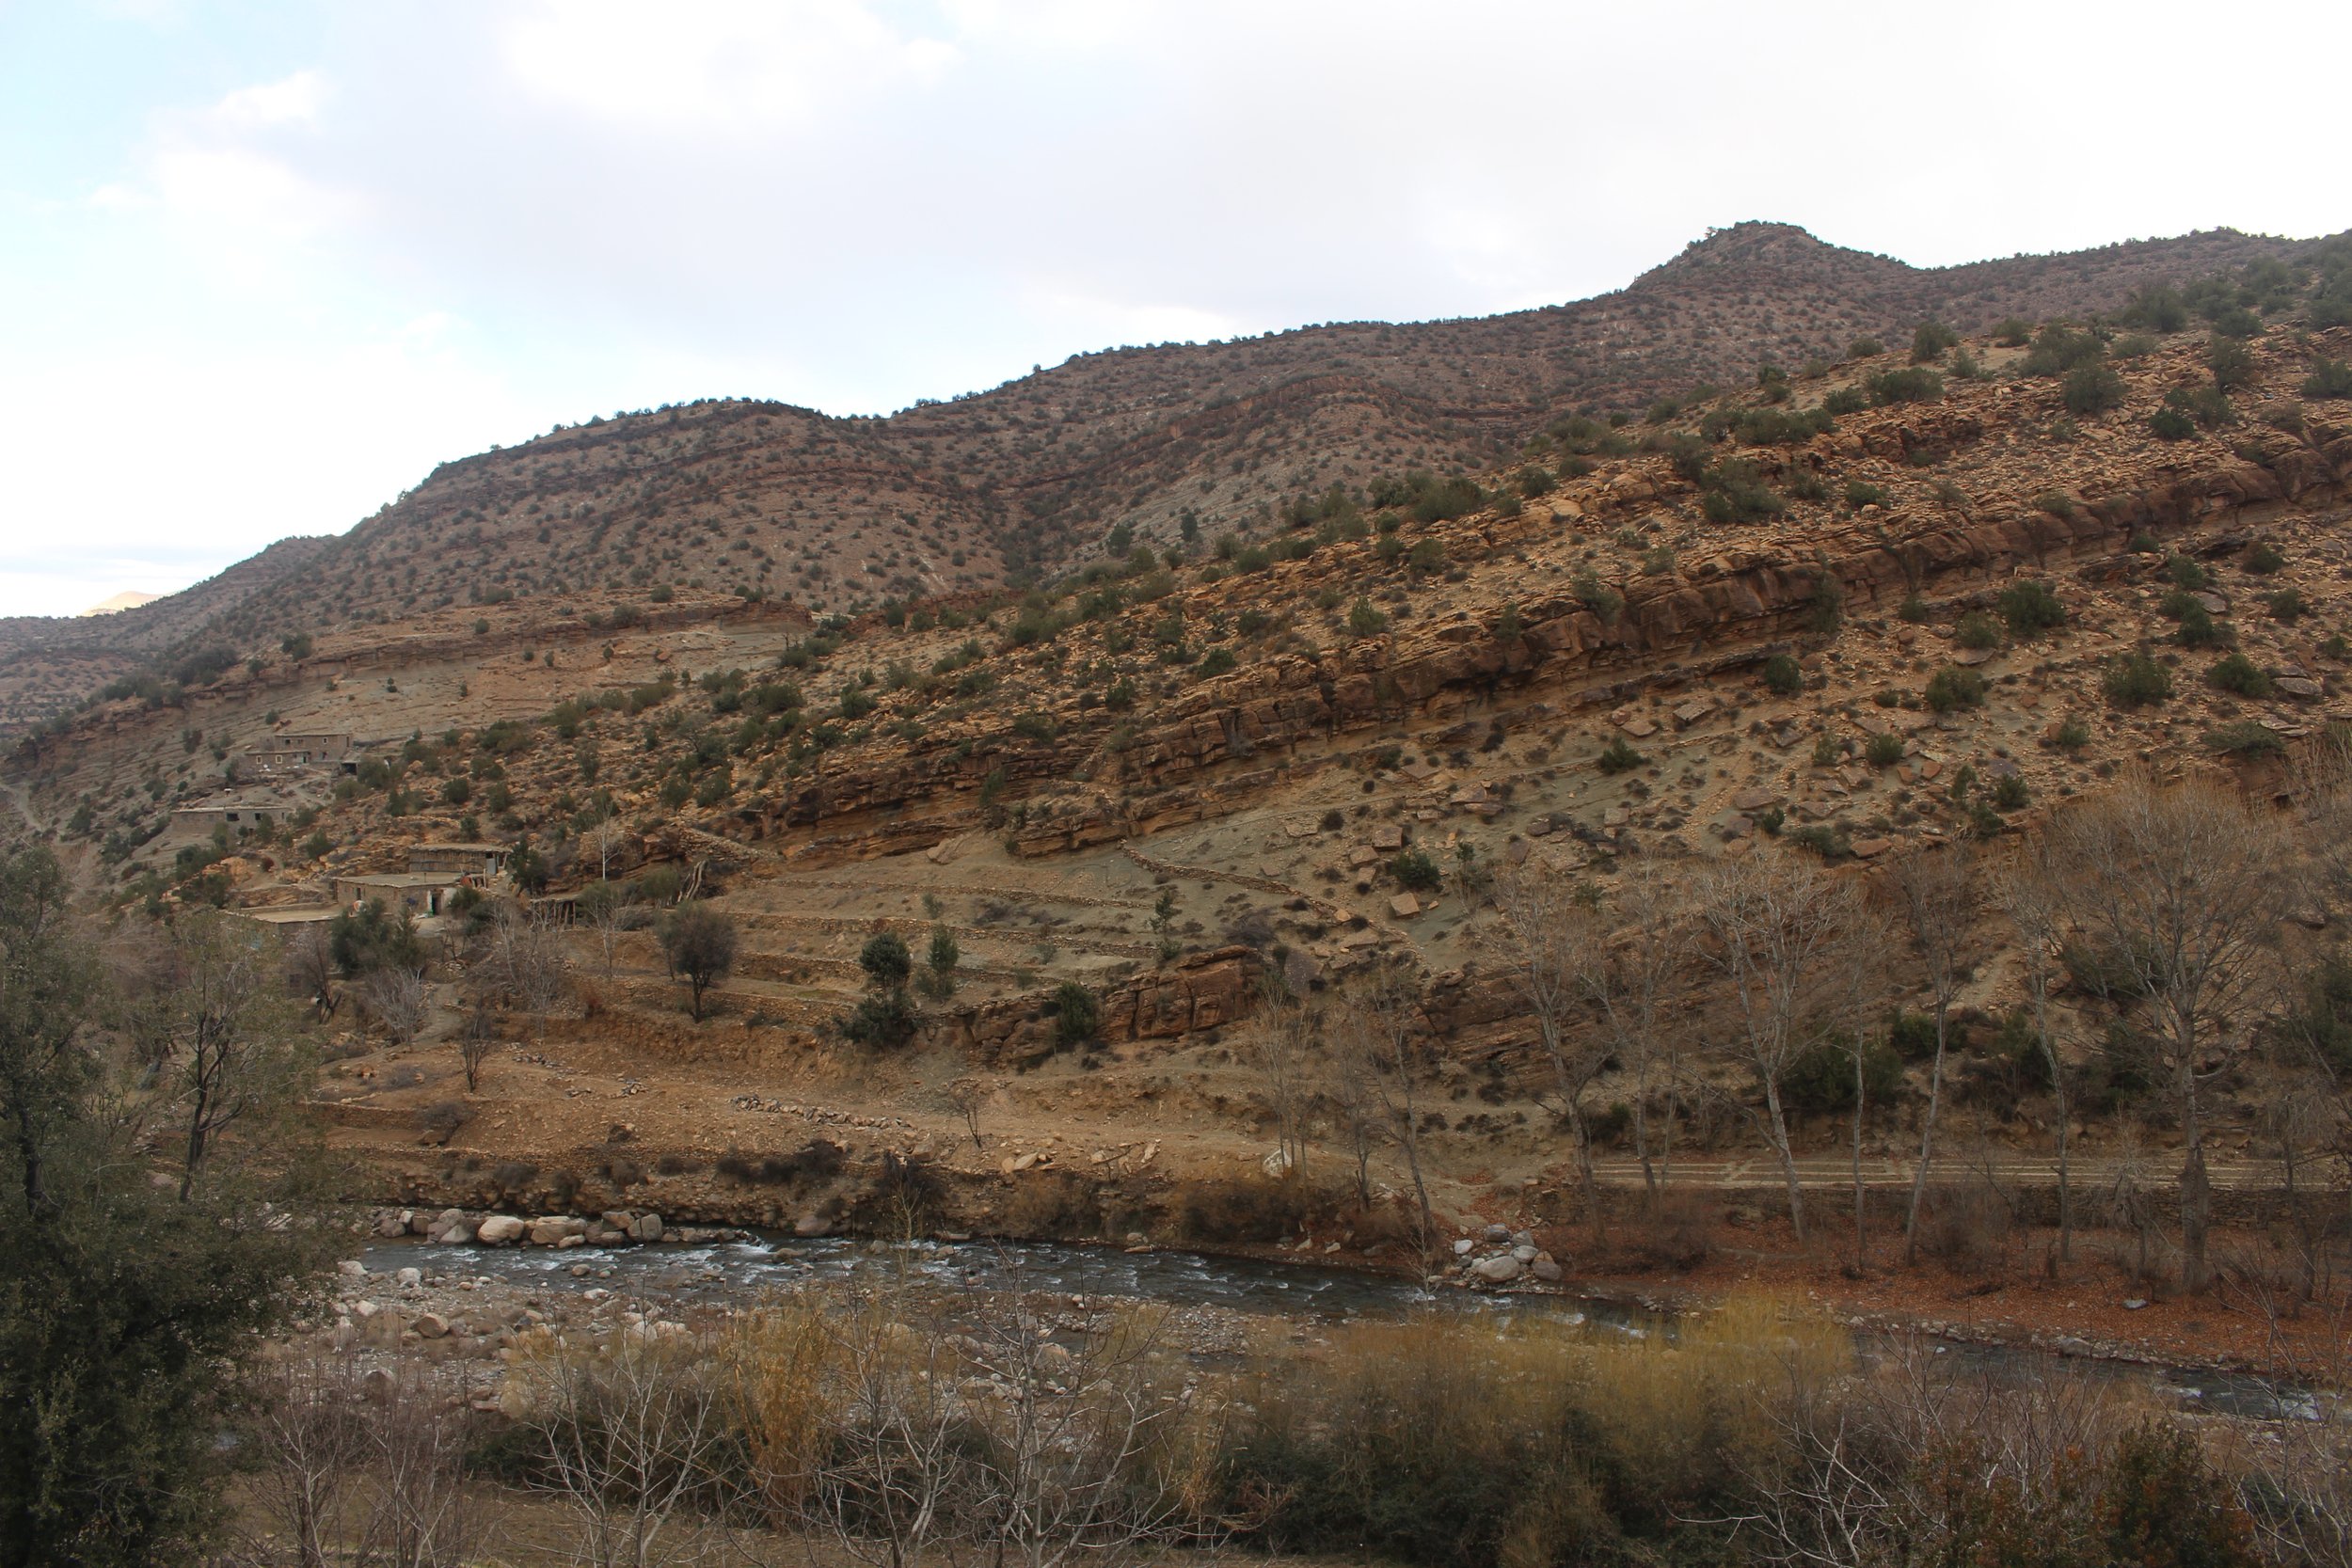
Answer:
9, 288, 2352, 1229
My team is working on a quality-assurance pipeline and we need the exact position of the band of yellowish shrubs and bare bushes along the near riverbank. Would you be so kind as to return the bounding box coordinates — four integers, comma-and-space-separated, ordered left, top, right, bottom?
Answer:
212, 1281, 2352, 1568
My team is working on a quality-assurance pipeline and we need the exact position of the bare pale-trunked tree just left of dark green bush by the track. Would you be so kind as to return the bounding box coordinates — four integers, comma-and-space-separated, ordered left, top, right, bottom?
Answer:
1696, 856, 1863, 1242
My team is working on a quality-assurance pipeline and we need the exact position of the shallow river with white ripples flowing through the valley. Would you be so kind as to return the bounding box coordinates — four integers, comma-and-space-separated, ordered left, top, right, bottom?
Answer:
362, 1237, 2324, 1420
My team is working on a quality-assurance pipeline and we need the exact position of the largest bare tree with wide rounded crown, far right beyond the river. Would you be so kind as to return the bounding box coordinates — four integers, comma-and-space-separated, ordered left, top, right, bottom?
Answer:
2051, 771, 2294, 1291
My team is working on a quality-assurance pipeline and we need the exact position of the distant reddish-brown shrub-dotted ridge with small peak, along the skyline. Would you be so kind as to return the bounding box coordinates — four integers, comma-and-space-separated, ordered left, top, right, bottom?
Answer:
0, 223, 2343, 742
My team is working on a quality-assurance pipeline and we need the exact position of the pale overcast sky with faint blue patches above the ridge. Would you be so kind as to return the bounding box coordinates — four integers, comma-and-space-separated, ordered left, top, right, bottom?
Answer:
0, 0, 2352, 613
